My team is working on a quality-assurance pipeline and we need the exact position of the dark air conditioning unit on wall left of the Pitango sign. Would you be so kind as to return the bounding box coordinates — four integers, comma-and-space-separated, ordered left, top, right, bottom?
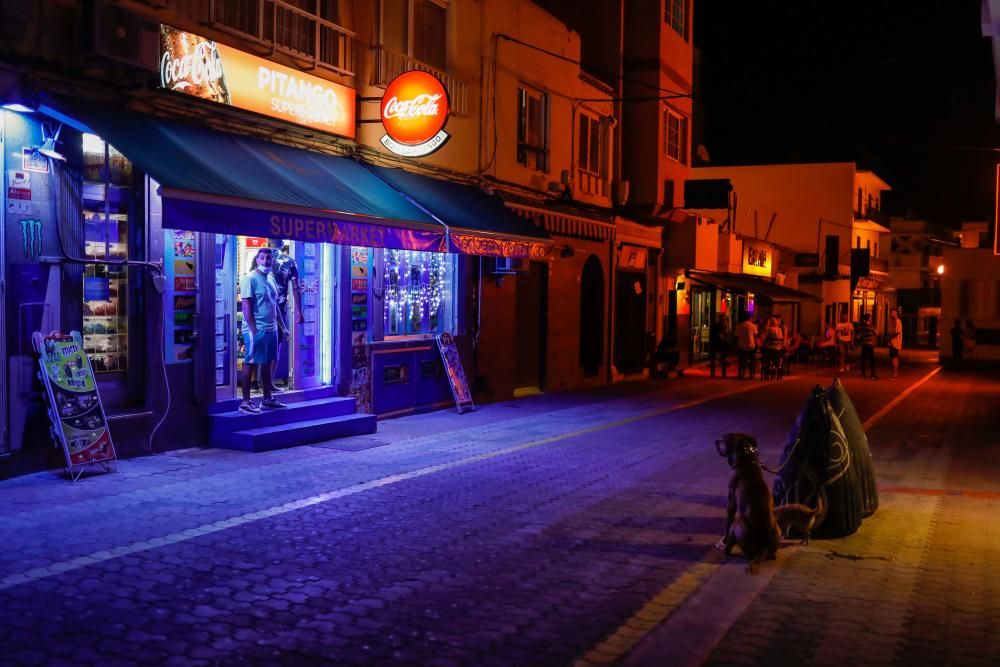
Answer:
81, 0, 160, 72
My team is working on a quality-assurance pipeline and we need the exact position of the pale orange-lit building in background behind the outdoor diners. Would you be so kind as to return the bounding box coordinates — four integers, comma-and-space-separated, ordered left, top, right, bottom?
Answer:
692, 163, 895, 348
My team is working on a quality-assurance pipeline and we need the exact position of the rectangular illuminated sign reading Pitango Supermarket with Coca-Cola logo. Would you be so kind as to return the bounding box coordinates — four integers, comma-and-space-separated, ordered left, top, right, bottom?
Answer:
160, 25, 355, 138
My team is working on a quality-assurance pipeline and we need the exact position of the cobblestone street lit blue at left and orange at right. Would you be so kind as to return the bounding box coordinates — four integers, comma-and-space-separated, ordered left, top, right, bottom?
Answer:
0, 355, 1000, 665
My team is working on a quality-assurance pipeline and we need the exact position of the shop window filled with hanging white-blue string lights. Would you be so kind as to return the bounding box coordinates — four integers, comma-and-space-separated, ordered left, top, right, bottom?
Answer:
380, 249, 456, 338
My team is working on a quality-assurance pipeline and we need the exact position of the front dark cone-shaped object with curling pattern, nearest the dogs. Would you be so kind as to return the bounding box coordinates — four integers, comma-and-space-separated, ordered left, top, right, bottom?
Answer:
773, 385, 862, 538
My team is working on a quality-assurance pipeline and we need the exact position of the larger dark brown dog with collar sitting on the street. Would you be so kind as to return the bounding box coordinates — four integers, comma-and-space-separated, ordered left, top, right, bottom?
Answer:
715, 433, 781, 572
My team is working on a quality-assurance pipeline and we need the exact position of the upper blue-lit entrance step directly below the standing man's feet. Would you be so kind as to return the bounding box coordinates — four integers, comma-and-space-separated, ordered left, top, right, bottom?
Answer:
209, 396, 375, 449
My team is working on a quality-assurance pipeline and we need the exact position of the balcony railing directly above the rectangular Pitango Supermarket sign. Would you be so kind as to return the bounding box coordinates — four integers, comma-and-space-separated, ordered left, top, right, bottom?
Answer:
209, 0, 354, 76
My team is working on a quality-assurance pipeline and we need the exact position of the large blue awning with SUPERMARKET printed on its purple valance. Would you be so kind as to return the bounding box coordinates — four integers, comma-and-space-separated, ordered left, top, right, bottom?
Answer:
47, 103, 445, 252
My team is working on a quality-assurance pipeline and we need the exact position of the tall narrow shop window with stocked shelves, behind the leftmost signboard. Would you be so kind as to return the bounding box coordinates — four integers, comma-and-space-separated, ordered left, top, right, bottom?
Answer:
82, 134, 132, 374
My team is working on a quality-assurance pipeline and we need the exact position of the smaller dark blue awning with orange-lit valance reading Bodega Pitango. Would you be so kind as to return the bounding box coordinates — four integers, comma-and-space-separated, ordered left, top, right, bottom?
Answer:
367, 165, 552, 259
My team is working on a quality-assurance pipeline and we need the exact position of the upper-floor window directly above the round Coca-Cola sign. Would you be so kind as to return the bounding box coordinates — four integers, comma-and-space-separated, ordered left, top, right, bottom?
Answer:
380, 0, 448, 71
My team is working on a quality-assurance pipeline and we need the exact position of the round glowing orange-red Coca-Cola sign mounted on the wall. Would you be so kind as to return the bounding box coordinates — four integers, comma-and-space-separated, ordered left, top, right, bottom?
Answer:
381, 70, 450, 157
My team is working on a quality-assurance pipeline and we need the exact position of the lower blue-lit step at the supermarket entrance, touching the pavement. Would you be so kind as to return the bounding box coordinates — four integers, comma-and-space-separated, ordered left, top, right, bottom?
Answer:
221, 414, 376, 452
